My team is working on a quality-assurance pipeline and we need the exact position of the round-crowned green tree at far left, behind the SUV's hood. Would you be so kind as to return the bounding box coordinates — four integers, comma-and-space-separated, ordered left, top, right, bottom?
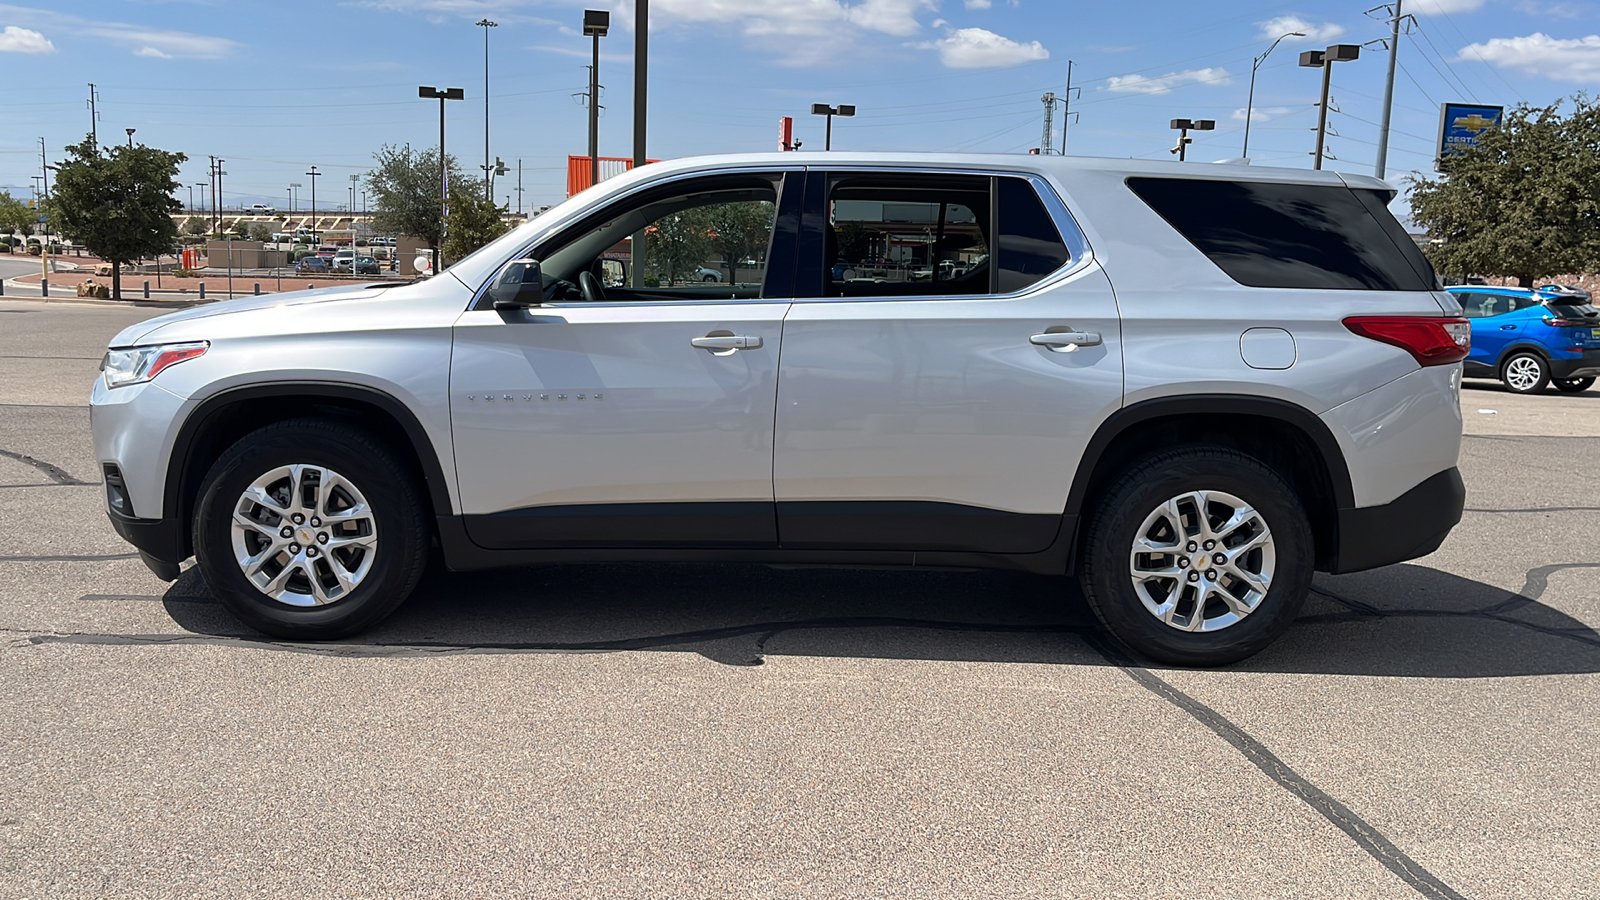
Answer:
46, 138, 189, 299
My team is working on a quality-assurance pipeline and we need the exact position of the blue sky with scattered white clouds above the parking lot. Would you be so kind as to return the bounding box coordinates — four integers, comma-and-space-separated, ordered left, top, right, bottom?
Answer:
0, 0, 1600, 210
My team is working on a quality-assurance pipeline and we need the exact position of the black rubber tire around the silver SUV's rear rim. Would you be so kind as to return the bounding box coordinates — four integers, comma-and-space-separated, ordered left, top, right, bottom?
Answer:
1078, 447, 1312, 666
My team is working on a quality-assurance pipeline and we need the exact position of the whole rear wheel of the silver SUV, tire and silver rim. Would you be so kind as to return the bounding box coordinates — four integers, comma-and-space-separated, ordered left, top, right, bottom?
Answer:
1080, 447, 1312, 666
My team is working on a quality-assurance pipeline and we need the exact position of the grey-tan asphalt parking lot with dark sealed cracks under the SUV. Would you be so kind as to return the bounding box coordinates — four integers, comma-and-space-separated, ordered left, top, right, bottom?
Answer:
0, 298, 1600, 898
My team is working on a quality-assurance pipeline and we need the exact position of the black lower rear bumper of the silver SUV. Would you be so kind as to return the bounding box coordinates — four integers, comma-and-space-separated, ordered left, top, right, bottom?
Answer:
1331, 466, 1467, 573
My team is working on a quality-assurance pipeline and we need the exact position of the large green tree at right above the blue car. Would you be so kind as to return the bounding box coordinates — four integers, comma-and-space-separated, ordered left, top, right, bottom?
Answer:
1408, 94, 1600, 287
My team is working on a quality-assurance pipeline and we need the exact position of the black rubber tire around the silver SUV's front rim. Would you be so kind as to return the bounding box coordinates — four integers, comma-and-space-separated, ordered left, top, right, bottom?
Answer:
194, 420, 429, 641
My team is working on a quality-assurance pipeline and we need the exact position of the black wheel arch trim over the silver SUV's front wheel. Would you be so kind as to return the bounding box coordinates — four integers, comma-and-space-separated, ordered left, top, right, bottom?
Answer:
162, 381, 451, 556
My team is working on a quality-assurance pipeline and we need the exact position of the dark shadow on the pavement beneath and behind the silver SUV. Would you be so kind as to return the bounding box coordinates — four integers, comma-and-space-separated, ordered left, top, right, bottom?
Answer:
152, 564, 1600, 677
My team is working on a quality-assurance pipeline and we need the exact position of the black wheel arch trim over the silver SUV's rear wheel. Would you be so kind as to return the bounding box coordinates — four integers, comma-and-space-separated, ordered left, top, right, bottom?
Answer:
1066, 394, 1355, 569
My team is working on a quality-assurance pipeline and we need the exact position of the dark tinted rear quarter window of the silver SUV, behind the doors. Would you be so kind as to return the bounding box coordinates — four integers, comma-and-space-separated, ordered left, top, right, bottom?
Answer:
1128, 178, 1437, 290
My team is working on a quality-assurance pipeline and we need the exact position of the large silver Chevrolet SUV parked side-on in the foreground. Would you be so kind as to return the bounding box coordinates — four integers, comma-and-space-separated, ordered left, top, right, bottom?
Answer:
84, 154, 1469, 665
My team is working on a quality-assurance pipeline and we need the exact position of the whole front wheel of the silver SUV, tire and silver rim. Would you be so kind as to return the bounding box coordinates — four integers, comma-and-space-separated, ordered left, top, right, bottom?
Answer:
194, 420, 427, 641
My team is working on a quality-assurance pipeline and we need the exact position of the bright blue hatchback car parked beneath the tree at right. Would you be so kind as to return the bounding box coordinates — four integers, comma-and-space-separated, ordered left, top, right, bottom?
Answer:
1448, 285, 1600, 394
